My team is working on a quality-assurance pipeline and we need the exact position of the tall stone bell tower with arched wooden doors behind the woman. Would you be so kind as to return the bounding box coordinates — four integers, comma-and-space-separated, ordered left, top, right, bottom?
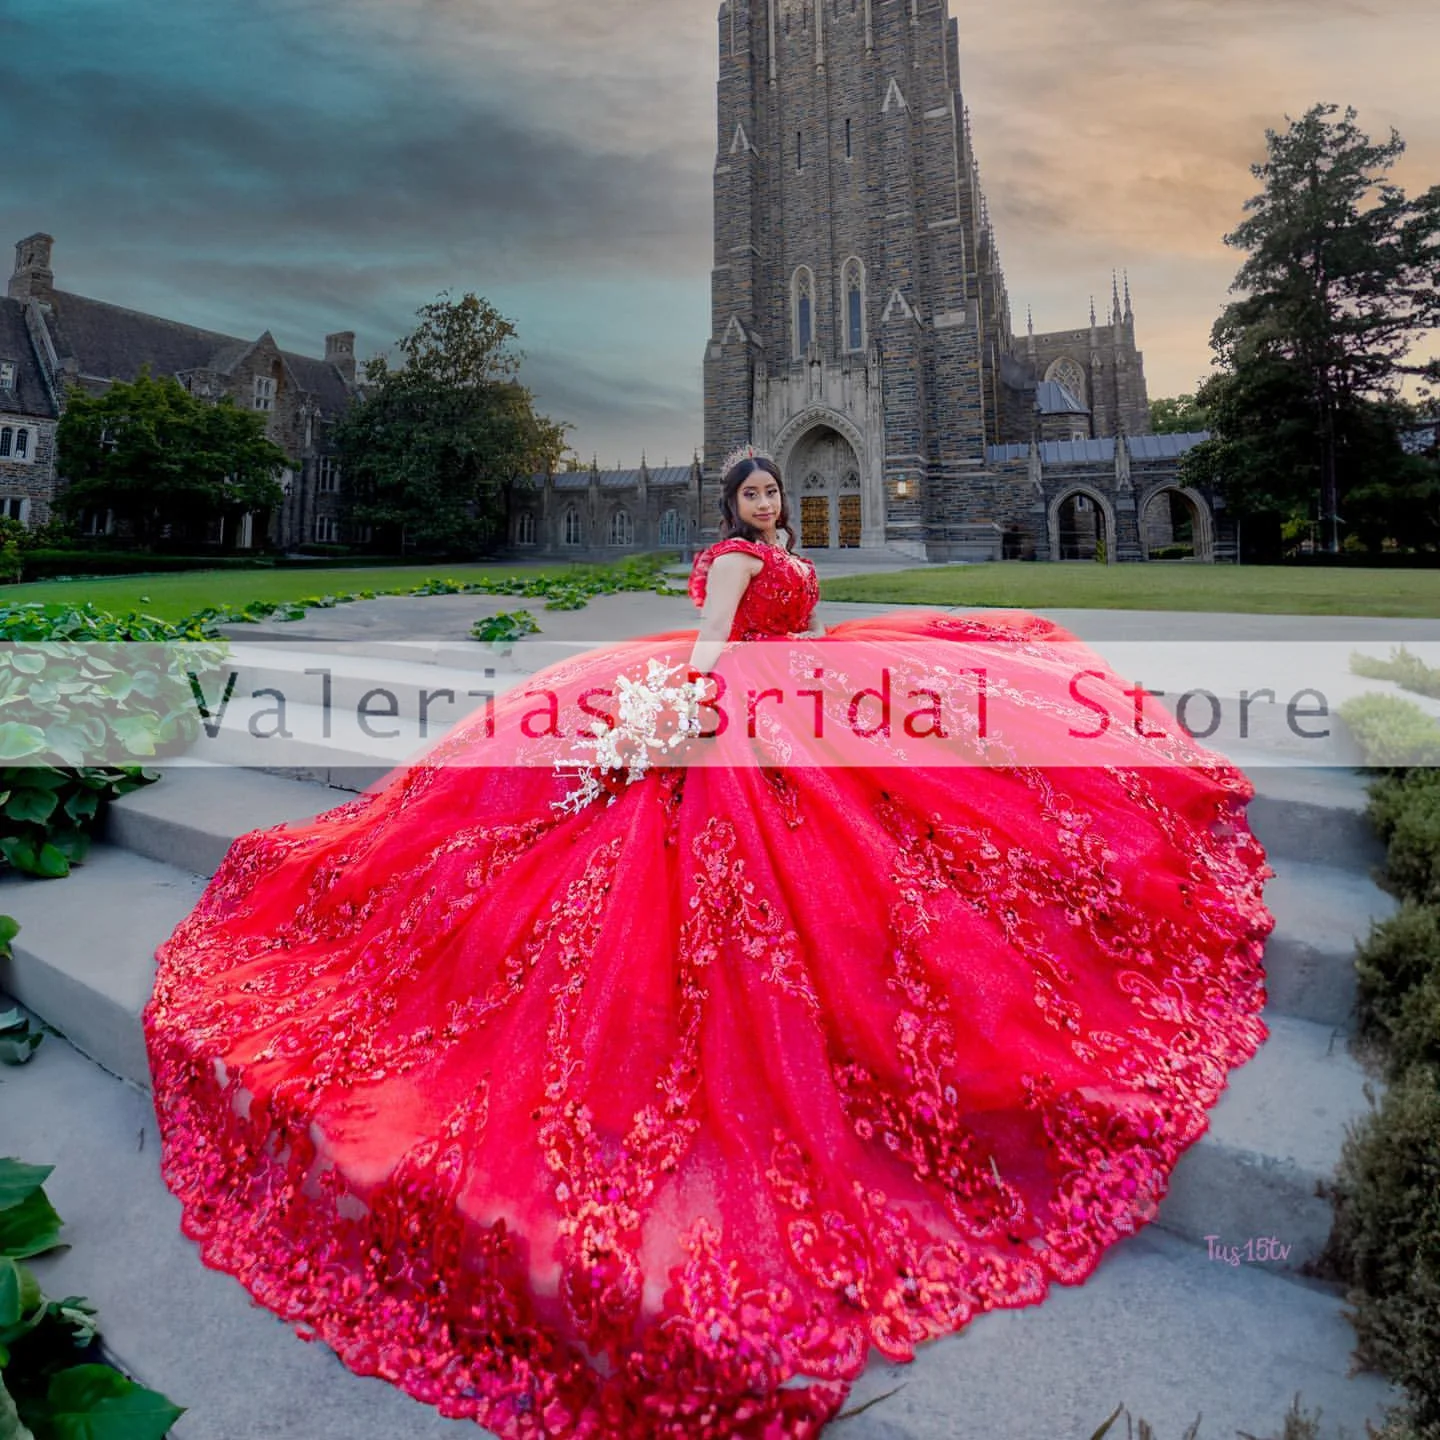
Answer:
701, 0, 1011, 557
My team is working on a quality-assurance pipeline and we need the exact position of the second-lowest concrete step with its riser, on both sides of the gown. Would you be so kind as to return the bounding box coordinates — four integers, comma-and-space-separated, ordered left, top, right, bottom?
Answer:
0, 845, 1368, 1269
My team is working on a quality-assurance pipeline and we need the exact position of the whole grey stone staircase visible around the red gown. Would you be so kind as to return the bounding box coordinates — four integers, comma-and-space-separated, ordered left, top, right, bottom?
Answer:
0, 644, 1394, 1440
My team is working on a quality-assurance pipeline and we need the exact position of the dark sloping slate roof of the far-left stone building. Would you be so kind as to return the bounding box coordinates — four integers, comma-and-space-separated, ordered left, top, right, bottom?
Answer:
37, 289, 350, 410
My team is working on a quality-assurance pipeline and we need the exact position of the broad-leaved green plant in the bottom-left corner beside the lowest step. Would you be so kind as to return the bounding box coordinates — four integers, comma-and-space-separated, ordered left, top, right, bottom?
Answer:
0, 1159, 184, 1440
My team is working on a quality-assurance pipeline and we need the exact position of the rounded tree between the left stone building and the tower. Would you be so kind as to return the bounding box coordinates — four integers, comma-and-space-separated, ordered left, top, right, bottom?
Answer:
334, 294, 569, 554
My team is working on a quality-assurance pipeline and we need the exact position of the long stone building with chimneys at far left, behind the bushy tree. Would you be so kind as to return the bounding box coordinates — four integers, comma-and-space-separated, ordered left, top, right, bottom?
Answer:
0, 235, 359, 549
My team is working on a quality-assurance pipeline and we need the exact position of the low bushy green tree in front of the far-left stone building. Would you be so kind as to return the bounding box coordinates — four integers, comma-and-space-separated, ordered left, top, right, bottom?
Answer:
56, 369, 289, 544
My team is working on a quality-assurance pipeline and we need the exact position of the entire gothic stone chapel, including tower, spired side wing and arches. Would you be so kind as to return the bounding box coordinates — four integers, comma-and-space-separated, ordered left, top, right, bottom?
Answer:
700, 0, 1234, 562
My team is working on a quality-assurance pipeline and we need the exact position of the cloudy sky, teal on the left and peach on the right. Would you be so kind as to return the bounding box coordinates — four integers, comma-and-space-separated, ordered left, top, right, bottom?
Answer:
0, 0, 1440, 465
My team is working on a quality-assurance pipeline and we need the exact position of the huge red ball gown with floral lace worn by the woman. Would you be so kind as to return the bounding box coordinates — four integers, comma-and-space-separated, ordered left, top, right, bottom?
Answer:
145, 540, 1273, 1440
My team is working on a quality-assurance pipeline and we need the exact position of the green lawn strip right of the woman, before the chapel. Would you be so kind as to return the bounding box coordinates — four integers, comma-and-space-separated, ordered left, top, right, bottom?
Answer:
824, 562, 1440, 619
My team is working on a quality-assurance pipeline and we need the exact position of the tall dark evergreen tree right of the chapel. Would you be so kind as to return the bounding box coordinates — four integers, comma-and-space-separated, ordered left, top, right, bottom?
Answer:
1185, 105, 1440, 550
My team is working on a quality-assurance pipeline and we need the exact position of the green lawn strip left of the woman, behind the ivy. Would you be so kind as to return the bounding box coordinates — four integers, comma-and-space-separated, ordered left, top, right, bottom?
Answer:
0, 562, 573, 621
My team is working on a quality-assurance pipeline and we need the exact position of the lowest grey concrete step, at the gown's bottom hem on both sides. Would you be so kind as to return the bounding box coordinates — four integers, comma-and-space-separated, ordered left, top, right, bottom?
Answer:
0, 1038, 1398, 1440
